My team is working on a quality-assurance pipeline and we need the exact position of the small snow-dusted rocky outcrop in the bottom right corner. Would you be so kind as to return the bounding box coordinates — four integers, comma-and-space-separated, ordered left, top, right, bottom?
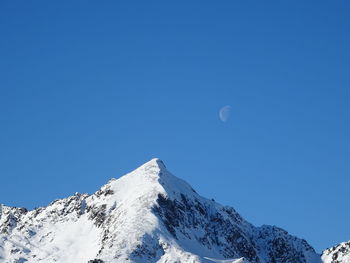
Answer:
322, 241, 350, 263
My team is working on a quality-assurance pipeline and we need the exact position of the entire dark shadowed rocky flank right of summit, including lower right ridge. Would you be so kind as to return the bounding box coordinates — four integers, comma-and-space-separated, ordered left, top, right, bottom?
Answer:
155, 192, 317, 263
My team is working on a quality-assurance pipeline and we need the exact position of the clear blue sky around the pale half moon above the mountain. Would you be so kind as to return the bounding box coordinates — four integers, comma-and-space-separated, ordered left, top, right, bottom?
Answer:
0, 0, 350, 254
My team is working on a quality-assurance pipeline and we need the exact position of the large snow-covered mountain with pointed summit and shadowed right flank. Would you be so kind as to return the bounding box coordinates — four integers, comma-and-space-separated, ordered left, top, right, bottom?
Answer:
0, 159, 350, 263
